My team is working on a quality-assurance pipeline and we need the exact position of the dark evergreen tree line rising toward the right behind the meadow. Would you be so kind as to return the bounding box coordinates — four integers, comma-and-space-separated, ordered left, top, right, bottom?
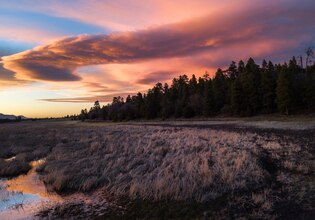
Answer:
73, 49, 315, 121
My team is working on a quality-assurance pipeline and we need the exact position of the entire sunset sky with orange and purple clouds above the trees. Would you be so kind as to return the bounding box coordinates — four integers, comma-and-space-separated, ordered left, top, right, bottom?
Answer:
0, 0, 315, 117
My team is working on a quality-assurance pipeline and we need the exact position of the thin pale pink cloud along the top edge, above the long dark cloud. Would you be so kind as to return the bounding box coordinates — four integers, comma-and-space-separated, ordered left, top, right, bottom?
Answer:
1, 0, 237, 31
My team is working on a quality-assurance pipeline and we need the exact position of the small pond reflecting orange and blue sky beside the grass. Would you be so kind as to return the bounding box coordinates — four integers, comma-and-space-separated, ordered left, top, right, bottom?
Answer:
0, 158, 62, 219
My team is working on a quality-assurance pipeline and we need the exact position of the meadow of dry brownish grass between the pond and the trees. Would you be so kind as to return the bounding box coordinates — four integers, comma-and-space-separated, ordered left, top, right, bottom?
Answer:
0, 120, 315, 219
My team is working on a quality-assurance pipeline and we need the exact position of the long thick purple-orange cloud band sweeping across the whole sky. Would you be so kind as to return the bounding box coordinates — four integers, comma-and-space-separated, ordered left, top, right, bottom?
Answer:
3, 1, 315, 83
